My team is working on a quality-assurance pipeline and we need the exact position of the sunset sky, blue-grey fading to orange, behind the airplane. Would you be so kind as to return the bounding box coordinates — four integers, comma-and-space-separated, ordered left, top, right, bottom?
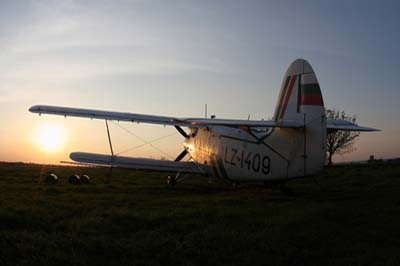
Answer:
0, 0, 400, 163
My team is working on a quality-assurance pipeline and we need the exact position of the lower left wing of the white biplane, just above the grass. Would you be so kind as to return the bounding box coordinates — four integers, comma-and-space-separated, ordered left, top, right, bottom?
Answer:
70, 152, 207, 174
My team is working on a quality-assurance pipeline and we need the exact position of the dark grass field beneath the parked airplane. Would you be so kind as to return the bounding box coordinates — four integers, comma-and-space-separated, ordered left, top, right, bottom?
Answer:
0, 163, 400, 266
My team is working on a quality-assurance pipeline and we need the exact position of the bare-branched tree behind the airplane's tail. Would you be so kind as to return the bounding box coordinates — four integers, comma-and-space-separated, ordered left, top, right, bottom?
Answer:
326, 109, 360, 166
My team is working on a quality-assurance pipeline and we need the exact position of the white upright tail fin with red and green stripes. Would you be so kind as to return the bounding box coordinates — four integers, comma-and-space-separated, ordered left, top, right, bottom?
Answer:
274, 59, 326, 175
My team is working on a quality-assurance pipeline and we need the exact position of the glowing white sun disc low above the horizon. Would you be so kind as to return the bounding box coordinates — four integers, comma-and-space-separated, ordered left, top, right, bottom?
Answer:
37, 125, 65, 152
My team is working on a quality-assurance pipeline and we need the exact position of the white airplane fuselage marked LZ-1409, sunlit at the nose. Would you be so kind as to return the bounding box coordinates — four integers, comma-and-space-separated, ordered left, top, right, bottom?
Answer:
184, 127, 319, 181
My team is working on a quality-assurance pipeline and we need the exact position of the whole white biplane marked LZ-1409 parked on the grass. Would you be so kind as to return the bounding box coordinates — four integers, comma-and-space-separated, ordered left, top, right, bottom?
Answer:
29, 59, 376, 185
